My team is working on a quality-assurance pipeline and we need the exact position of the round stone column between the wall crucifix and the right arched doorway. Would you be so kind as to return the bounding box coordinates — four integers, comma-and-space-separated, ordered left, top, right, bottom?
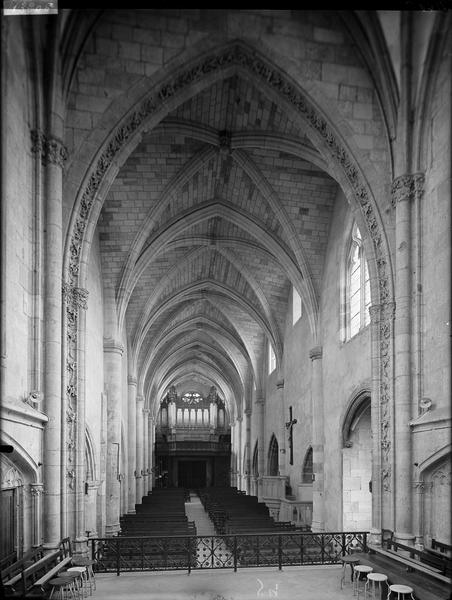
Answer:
309, 346, 325, 531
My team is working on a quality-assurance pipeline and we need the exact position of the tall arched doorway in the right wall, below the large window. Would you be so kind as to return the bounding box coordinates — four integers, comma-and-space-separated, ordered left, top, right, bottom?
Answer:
342, 393, 372, 531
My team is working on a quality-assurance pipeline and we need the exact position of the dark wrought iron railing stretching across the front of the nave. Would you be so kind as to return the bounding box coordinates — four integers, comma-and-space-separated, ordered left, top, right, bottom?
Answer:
90, 531, 367, 575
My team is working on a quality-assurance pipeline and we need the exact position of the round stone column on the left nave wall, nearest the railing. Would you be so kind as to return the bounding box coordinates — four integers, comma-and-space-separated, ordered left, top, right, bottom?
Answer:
104, 338, 124, 537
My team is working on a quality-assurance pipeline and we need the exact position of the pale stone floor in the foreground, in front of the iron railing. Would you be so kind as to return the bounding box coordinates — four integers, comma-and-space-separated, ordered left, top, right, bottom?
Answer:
92, 565, 356, 600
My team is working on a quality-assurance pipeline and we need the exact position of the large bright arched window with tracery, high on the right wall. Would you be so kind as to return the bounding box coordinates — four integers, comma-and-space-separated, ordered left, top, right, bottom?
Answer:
346, 223, 370, 339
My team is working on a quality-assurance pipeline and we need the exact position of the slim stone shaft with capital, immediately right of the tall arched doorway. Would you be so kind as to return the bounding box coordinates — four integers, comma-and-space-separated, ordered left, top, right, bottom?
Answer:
369, 304, 382, 546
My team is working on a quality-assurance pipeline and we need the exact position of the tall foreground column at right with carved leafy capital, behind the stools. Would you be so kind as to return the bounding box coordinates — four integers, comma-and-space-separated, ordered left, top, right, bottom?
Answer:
392, 173, 424, 544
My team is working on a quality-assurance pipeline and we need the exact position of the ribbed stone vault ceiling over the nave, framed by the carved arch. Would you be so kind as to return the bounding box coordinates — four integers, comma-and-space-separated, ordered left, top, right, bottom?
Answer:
98, 75, 337, 418
